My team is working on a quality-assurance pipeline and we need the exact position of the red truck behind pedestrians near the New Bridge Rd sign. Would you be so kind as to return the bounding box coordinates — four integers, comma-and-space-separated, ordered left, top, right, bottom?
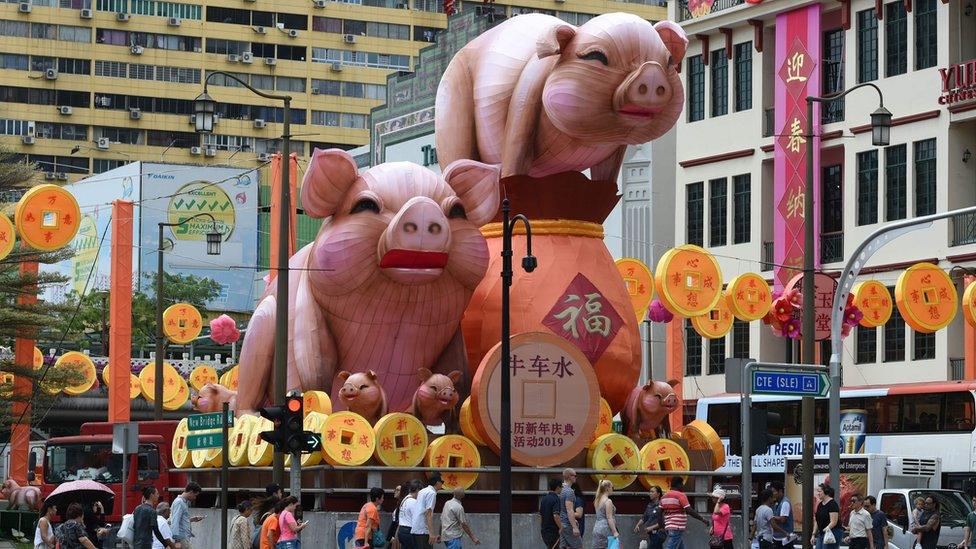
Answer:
28, 421, 186, 522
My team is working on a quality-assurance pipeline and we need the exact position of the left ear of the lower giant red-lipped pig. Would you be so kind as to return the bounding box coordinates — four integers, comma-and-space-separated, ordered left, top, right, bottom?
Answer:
302, 149, 359, 219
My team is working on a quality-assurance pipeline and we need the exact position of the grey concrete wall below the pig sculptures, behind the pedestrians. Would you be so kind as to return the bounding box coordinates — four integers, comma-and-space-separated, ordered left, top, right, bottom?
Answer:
187, 509, 742, 549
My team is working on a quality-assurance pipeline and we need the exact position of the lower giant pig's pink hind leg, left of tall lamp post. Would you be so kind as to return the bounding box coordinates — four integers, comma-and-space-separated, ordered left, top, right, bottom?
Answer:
236, 295, 276, 413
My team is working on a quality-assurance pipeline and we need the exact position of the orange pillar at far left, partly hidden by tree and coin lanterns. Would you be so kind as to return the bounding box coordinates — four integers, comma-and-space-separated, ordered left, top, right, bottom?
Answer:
7, 262, 37, 486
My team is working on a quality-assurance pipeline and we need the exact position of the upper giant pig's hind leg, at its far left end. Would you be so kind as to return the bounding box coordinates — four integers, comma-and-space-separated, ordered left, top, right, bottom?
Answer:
434, 55, 479, 166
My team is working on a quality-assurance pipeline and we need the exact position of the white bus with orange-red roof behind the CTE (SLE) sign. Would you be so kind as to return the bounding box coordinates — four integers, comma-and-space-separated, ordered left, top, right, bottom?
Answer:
695, 381, 976, 492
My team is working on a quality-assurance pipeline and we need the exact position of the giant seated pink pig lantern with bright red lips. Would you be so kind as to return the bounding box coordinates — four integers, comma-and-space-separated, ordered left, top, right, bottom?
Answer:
228, 149, 499, 413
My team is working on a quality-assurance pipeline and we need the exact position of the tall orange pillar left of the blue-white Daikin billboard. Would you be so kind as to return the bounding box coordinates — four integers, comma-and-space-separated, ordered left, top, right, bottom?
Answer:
108, 200, 132, 423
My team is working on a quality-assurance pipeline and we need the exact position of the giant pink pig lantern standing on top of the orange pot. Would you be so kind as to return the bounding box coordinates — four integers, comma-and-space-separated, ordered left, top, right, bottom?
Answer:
434, 13, 688, 181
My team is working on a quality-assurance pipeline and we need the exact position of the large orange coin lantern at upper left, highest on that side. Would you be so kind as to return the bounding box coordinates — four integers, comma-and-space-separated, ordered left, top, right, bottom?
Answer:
14, 185, 81, 252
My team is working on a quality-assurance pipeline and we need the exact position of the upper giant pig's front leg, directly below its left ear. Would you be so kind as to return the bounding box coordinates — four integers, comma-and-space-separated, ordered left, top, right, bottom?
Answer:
502, 55, 559, 177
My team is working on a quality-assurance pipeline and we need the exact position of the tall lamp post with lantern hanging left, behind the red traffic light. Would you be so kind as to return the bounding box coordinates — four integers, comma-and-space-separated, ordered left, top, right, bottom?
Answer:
193, 71, 292, 485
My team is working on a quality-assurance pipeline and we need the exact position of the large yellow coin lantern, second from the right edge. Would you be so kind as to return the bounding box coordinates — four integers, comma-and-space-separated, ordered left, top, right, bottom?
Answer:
895, 262, 959, 334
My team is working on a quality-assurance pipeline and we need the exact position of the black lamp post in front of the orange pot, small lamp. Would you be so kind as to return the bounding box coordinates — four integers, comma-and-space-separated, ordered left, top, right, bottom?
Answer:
498, 198, 538, 547
